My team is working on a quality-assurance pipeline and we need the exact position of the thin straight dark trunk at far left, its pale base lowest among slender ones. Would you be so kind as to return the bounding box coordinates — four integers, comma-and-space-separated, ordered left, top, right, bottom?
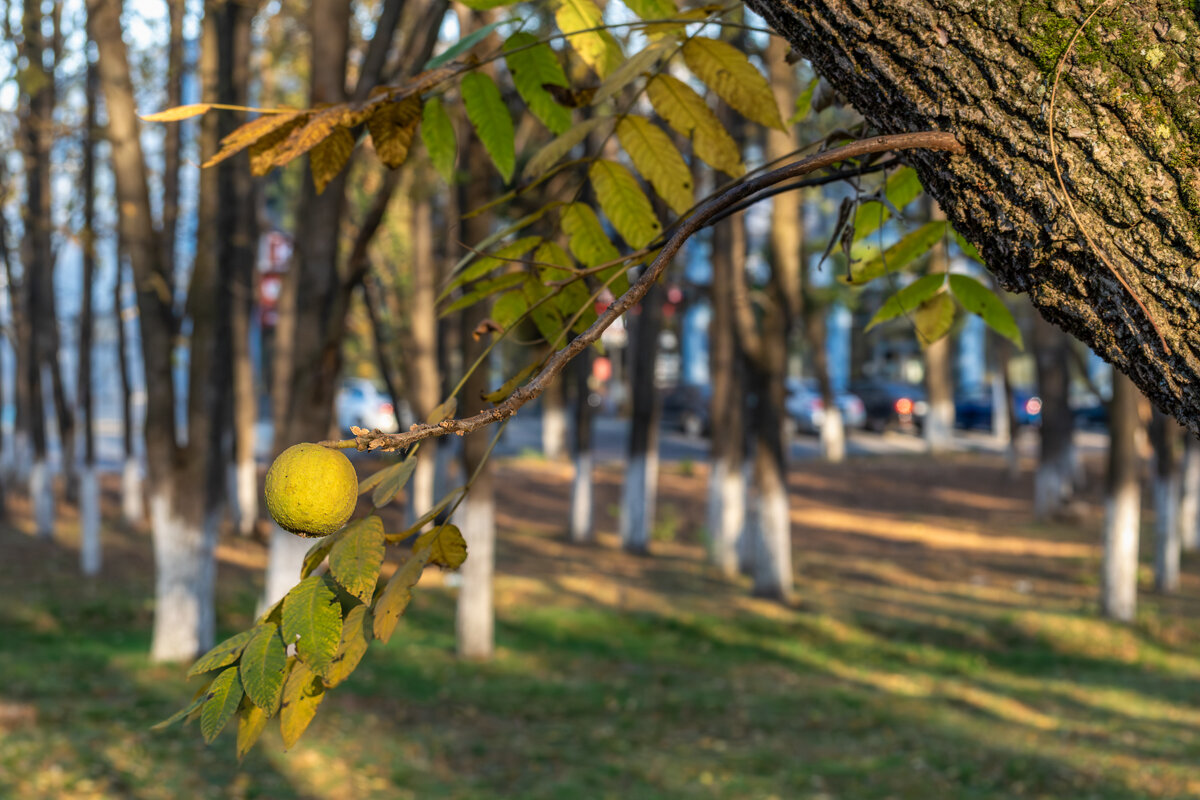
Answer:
76, 61, 101, 575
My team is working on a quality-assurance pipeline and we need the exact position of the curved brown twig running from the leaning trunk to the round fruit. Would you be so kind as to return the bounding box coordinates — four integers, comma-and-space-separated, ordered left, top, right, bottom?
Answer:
320, 131, 966, 451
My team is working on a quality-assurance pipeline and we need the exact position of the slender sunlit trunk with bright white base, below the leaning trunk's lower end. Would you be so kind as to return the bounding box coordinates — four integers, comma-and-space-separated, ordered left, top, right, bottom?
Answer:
1100, 373, 1141, 622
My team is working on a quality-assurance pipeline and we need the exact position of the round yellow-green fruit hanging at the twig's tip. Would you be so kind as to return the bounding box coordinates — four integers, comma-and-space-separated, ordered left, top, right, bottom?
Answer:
265, 443, 359, 537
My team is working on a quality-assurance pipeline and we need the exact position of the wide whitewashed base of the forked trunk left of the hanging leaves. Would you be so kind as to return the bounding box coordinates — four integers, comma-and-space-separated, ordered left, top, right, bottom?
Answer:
150, 494, 220, 661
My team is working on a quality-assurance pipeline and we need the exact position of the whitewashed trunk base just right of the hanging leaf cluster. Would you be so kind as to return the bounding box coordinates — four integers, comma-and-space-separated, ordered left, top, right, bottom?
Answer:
455, 493, 496, 660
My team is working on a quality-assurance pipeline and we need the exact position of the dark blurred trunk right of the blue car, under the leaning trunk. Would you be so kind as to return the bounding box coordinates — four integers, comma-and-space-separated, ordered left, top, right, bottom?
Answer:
1033, 317, 1075, 519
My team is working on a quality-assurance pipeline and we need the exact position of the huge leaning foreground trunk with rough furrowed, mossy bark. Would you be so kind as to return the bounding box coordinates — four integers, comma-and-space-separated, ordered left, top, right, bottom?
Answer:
748, 0, 1200, 433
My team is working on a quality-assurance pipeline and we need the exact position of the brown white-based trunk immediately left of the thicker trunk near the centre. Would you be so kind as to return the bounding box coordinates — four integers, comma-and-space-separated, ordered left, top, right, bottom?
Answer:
708, 213, 746, 578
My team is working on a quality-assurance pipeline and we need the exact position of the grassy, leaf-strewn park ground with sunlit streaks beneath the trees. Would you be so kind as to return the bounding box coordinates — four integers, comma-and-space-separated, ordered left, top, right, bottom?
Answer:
0, 456, 1200, 800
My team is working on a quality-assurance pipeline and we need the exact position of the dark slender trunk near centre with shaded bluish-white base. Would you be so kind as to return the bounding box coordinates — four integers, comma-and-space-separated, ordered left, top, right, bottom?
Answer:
620, 284, 664, 555
